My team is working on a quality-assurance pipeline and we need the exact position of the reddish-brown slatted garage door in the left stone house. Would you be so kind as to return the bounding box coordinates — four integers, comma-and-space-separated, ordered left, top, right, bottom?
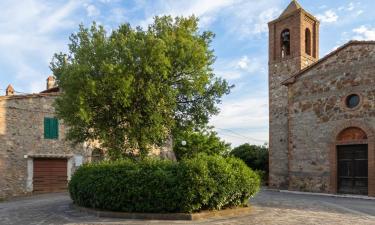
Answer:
33, 159, 68, 193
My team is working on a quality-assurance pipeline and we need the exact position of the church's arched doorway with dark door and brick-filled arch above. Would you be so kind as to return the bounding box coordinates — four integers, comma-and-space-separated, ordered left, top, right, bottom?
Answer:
336, 127, 368, 195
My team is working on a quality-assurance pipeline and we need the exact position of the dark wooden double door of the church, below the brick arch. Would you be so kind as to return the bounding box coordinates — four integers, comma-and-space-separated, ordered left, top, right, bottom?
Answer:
337, 145, 368, 195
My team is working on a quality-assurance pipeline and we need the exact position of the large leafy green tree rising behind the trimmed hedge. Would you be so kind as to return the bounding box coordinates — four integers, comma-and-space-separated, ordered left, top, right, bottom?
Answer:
51, 16, 231, 158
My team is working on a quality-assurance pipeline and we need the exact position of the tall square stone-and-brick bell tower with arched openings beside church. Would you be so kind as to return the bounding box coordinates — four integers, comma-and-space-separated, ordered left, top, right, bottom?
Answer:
268, 0, 319, 189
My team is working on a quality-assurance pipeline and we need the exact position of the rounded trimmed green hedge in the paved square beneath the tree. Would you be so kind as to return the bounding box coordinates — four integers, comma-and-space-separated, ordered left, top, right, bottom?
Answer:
69, 155, 260, 213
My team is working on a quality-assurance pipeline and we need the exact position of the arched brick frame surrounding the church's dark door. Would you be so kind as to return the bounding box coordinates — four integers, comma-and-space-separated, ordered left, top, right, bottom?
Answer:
329, 121, 375, 197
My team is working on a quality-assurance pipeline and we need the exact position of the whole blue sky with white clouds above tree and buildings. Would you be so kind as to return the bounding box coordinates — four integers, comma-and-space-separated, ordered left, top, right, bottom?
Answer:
0, 0, 375, 146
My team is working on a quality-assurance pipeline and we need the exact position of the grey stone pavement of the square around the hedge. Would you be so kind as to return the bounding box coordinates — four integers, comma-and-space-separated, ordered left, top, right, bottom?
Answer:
0, 190, 375, 225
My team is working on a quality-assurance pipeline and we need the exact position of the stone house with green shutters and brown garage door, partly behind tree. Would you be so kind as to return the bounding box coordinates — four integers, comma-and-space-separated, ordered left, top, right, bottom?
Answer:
0, 76, 175, 199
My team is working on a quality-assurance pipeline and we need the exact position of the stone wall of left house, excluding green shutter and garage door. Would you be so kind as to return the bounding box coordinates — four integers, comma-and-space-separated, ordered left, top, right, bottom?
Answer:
0, 94, 90, 198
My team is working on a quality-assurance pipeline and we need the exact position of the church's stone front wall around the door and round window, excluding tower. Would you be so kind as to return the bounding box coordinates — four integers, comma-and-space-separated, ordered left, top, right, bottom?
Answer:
289, 43, 375, 192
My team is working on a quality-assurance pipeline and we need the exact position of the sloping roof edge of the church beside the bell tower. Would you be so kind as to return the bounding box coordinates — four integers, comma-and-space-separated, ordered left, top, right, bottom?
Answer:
282, 41, 375, 85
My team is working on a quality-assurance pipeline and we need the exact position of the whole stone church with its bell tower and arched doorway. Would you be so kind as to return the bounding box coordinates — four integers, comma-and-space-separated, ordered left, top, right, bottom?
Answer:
268, 1, 375, 196
